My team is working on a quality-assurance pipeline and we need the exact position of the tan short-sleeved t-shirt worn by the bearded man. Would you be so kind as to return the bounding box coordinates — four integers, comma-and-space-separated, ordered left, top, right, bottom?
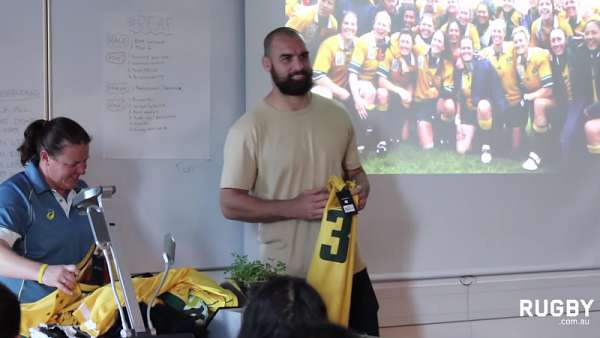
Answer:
221, 95, 364, 277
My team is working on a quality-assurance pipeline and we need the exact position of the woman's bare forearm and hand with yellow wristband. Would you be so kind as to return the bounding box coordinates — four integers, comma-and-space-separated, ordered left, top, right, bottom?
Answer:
0, 239, 79, 294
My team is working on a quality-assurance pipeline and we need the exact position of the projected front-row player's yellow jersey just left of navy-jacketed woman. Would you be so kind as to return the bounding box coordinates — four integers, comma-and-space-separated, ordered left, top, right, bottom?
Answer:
414, 52, 454, 102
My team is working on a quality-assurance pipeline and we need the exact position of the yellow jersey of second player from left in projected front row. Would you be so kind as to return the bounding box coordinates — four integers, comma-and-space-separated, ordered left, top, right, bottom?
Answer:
348, 32, 390, 81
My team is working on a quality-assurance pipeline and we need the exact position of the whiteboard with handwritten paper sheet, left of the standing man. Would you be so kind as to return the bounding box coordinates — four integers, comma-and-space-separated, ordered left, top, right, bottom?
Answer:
52, 0, 243, 272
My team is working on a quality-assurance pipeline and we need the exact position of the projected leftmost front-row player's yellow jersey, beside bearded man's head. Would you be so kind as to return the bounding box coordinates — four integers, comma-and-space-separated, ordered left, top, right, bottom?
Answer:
313, 34, 357, 87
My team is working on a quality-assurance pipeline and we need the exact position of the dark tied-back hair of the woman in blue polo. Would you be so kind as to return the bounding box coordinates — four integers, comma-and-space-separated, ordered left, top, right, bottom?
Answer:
17, 117, 92, 165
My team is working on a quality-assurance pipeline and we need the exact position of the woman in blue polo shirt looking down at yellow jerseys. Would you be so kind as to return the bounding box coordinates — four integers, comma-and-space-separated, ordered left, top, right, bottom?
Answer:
0, 117, 94, 303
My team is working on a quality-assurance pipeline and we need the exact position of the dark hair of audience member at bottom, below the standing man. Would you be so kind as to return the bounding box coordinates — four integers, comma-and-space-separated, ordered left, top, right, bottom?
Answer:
238, 276, 327, 338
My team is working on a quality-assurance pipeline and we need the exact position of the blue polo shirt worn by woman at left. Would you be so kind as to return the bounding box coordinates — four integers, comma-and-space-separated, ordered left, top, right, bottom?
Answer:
0, 162, 94, 303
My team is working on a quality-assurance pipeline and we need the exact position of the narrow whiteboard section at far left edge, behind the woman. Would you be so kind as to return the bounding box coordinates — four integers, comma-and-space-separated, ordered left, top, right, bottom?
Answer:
0, 0, 44, 182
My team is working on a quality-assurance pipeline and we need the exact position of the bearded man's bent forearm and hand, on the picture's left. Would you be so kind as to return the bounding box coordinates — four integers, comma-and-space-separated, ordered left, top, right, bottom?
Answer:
220, 188, 329, 223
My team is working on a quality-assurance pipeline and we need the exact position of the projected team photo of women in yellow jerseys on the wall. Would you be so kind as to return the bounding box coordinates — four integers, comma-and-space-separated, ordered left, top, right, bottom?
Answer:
282, 0, 600, 174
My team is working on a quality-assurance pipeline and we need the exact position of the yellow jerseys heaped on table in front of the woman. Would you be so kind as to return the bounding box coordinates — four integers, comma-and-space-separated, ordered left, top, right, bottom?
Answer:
20, 268, 238, 337
